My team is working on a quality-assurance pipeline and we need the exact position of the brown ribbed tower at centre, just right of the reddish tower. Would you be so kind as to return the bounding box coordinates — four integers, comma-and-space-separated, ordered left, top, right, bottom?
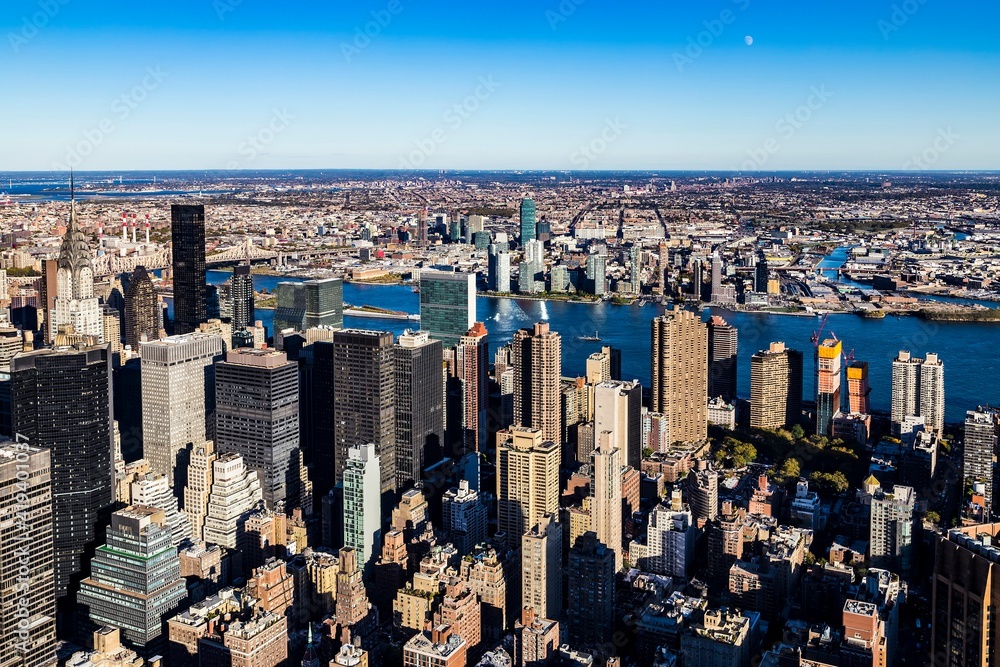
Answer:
511, 322, 562, 444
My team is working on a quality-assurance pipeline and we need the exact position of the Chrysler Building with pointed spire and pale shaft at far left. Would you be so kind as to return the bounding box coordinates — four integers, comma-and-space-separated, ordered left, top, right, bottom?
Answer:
48, 185, 104, 343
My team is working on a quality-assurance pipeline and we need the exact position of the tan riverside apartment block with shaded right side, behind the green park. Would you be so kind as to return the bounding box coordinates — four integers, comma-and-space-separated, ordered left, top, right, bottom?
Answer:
750, 343, 802, 429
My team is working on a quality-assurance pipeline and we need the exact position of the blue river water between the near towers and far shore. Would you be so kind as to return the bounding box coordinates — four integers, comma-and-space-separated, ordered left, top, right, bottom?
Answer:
208, 271, 1000, 422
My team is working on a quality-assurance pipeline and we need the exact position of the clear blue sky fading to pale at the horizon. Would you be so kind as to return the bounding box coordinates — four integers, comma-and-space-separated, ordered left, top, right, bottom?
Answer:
0, 0, 1000, 170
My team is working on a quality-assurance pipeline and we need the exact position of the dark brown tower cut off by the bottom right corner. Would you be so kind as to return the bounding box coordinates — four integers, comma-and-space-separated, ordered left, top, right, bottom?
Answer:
929, 523, 1000, 667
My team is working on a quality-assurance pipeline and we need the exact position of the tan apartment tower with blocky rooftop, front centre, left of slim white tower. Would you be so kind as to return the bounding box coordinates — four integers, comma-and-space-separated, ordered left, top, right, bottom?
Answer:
497, 426, 560, 547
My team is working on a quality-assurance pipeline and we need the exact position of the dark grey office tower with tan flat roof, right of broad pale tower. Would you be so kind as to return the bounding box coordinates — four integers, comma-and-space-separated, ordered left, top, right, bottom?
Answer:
215, 348, 302, 512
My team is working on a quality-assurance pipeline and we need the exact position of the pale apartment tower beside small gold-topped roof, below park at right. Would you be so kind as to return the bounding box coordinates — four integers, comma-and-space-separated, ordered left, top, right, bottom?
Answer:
868, 484, 916, 575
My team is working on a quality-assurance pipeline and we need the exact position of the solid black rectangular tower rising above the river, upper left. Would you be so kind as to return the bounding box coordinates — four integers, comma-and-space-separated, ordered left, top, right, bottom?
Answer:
170, 204, 208, 334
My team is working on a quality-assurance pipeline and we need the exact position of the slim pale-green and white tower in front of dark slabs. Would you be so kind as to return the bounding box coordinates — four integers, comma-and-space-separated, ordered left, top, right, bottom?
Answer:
344, 444, 382, 569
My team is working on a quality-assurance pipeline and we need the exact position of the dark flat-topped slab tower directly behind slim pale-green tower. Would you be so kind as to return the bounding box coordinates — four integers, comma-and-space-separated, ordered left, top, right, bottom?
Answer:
328, 329, 396, 493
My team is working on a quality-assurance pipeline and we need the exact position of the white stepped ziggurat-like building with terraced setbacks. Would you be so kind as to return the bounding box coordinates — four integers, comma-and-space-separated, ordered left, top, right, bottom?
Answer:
204, 454, 264, 549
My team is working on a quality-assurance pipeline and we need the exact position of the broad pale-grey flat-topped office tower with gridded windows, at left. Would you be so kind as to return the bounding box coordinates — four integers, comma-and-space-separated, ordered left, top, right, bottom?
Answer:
141, 333, 222, 486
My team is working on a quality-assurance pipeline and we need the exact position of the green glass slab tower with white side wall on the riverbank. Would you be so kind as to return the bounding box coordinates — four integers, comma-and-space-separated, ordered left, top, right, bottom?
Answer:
420, 271, 476, 347
